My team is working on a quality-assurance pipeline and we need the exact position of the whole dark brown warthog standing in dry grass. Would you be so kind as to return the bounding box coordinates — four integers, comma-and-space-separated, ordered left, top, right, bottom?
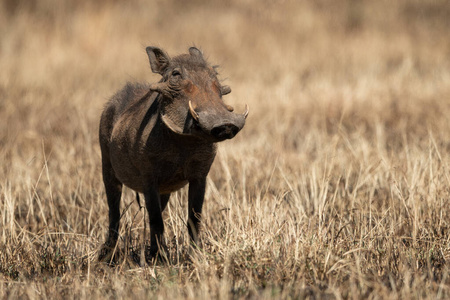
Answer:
100, 47, 248, 259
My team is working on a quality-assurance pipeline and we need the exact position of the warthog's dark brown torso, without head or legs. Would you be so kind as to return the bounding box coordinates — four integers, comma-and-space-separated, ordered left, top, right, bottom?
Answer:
102, 84, 216, 194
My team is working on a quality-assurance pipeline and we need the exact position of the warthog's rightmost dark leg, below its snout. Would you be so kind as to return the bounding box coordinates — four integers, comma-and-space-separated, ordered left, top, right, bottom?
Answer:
188, 177, 206, 244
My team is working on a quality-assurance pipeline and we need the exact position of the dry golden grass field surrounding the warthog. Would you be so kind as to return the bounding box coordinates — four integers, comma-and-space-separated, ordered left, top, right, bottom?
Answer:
0, 0, 450, 299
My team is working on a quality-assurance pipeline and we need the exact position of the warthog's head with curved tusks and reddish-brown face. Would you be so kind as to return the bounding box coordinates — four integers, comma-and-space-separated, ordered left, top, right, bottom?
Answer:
146, 47, 248, 142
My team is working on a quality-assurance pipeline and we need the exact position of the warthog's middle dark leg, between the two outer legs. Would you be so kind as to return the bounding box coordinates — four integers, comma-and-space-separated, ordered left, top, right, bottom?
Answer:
144, 186, 164, 258
